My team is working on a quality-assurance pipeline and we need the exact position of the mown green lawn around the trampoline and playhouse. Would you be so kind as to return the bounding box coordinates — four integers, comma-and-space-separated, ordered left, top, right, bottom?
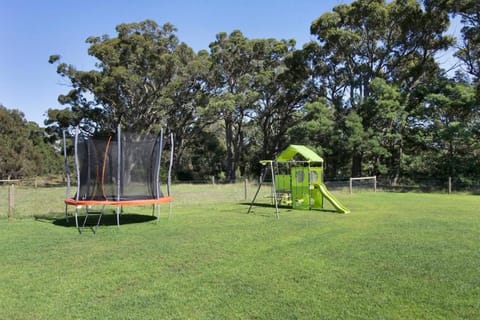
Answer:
0, 185, 480, 319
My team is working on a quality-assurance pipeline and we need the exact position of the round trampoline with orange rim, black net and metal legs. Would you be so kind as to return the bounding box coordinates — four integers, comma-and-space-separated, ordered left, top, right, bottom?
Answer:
63, 127, 174, 233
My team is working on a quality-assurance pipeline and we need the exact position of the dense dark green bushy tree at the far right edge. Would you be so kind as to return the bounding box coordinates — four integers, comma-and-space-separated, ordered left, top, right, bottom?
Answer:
410, 77, 480, 179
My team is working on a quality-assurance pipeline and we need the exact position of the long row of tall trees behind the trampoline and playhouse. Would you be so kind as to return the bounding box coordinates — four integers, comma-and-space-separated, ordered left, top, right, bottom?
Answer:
1, 0, 480, 184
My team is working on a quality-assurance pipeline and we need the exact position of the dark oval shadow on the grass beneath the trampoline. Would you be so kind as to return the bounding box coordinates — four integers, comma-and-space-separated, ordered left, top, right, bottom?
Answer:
35, 212, 157, 228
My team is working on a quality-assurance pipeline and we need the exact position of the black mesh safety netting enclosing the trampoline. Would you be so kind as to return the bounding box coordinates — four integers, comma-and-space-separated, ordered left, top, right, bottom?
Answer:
77, 133, 163, 201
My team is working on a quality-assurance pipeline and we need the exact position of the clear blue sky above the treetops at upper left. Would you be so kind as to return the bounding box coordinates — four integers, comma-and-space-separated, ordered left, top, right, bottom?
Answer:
0, 0, 458, 126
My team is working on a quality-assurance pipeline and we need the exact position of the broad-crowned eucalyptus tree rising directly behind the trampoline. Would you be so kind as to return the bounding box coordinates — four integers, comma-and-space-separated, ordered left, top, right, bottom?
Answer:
46, 20, 219, 180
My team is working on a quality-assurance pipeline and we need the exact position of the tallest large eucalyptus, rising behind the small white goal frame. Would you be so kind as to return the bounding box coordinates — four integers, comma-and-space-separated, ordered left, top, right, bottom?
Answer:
305, 0, 453, 178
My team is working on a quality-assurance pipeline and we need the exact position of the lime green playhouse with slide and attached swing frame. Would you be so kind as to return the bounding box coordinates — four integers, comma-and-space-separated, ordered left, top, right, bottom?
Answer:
248, 145, 350, 218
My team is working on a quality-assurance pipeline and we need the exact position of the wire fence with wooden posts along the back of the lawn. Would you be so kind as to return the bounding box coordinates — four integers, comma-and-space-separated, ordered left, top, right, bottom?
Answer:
0, 175, 480, 219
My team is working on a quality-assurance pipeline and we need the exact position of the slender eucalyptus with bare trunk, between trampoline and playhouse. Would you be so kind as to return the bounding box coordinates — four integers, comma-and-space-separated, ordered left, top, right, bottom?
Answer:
208, 30, 258, 182
